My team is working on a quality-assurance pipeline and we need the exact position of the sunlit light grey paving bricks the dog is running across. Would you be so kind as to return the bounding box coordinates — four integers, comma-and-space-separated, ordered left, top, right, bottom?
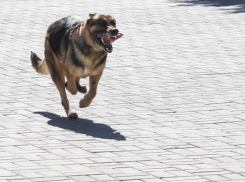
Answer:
0, 0, 245, 182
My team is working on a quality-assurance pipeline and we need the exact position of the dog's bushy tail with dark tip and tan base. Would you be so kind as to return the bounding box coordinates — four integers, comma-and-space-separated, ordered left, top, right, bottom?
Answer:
31, 52, 49, 75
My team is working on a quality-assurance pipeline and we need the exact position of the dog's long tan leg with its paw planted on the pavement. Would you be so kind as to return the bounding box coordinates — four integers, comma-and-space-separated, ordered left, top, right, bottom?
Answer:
45, 47, 78, 119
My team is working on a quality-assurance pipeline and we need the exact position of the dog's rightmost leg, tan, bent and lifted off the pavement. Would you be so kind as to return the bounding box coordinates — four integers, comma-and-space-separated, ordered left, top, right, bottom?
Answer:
80, 73, 102, 108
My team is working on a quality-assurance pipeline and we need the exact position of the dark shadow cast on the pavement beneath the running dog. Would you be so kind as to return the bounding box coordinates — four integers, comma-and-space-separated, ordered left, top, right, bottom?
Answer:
34, 112, 126, 140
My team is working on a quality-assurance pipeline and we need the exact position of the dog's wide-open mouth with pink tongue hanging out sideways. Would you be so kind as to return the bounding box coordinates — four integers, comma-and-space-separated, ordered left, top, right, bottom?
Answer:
97, 33, 123, 53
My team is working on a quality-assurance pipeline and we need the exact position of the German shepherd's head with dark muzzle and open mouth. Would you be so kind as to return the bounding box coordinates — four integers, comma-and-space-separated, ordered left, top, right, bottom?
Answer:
85, 14, 123, 53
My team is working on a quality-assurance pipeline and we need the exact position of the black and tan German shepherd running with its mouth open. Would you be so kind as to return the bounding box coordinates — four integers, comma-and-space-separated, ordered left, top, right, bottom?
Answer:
31, 13, 123, 119
